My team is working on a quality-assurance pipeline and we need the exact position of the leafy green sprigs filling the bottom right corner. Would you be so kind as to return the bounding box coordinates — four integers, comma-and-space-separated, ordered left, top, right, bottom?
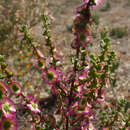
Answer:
99, 99, 130, 130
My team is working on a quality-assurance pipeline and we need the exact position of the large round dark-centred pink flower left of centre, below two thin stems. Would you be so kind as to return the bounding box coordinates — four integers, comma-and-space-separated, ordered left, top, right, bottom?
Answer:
42, 68, 59, 84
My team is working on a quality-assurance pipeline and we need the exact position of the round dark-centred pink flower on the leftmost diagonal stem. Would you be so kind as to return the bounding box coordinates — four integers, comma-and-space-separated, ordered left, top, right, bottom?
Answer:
8, 81, 22, 96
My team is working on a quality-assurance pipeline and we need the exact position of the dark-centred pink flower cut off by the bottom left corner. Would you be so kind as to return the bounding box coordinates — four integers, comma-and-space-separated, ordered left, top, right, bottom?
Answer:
0, 116, 18, 130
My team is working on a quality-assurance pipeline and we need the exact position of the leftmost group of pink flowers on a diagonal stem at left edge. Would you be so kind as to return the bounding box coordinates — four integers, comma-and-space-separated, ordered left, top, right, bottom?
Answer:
0, 60, 41, 130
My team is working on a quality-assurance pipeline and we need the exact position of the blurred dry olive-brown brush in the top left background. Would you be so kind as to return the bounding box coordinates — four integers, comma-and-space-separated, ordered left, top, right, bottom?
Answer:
0, 0, 44, 54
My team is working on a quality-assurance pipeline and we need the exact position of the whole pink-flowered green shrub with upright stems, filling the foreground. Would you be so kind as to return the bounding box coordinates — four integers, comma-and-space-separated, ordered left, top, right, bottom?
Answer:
0, 0, 129, 130
